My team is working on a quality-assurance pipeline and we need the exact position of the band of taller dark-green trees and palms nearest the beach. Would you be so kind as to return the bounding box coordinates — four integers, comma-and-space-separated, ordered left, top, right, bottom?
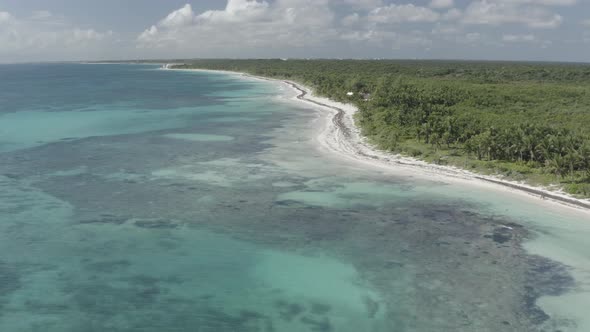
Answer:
359, 80, 590, 182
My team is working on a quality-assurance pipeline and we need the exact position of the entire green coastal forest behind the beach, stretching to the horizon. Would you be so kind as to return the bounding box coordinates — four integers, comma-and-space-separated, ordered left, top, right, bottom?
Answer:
173, 59, 590, 197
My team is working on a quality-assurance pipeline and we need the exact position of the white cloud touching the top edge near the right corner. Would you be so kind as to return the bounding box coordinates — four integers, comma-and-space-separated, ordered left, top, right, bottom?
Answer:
463, 0, 563, 29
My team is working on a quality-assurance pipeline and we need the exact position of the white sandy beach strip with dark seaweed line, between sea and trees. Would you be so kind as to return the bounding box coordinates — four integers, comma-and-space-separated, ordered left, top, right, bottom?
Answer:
165, 68, 590, 214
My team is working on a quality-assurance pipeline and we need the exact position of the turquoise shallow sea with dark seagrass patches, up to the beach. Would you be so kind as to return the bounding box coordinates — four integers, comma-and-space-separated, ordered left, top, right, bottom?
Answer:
0, 64, 590, 332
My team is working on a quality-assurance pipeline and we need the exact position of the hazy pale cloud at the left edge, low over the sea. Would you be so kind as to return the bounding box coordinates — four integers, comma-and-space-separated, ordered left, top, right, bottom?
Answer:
0, 11, 113, 61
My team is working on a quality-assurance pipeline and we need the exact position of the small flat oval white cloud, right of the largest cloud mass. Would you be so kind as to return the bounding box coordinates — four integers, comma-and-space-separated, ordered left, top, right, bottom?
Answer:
368, 4, 440, 23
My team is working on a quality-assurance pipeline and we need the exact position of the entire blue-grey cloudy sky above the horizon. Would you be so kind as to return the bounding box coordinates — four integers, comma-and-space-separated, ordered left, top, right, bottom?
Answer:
0, 0, 590, 63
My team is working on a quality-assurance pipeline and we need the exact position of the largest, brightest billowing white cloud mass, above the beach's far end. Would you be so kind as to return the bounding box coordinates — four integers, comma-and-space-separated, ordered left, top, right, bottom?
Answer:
137, 0, 338, 56
